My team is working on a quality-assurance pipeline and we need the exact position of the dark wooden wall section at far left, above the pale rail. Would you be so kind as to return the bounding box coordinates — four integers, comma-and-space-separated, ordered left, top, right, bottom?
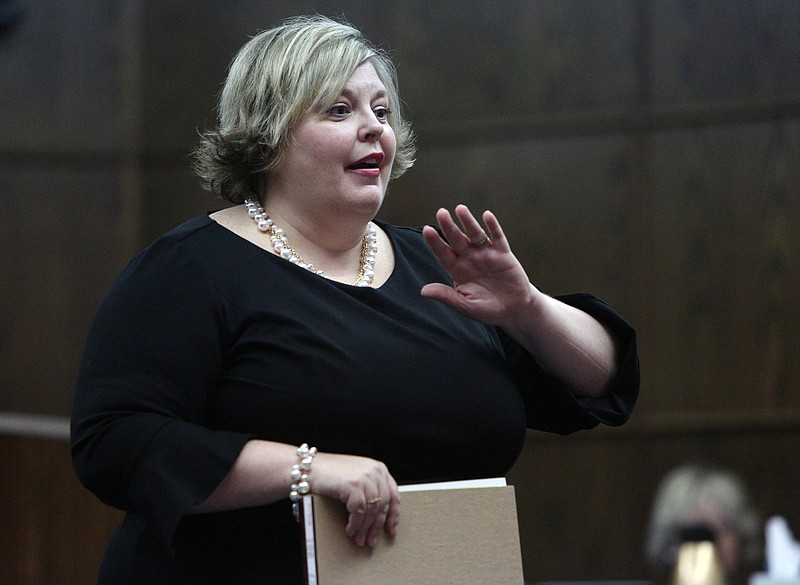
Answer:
0, 1, 147, 415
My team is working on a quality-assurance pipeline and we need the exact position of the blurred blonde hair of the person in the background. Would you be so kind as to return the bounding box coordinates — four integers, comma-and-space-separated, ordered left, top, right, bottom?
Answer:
646, 464, 761, 567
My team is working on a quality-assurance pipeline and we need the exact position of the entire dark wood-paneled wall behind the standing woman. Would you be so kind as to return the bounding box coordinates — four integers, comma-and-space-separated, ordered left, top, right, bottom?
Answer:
0, 0, 800, 585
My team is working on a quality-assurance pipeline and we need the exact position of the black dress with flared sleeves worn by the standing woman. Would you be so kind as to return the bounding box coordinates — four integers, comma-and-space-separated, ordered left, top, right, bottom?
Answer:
72, 216, 638, 585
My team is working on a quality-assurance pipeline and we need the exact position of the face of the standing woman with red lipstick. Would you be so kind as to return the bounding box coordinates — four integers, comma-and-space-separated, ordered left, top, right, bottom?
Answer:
266, 61, 397, 219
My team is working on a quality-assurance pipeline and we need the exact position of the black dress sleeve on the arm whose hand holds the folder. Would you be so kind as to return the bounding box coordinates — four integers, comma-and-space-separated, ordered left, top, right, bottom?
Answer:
71, 237, 250, 544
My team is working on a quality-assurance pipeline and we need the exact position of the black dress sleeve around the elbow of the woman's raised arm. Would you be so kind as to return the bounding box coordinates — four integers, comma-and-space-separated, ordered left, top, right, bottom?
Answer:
500, 293, 639, 435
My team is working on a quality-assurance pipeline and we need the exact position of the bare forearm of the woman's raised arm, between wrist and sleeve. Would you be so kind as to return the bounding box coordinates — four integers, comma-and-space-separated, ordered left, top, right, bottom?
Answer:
502, 285, 616, 396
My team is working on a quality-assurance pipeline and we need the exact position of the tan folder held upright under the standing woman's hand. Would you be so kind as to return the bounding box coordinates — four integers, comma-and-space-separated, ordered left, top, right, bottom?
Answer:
303, 486, 524, 585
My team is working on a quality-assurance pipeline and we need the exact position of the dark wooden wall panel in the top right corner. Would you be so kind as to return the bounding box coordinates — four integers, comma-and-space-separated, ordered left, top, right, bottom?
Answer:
650, 0, 800, 105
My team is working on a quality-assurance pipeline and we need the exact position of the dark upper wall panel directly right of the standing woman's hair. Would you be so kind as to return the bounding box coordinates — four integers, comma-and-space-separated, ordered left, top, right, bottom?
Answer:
390, 0, 636, 125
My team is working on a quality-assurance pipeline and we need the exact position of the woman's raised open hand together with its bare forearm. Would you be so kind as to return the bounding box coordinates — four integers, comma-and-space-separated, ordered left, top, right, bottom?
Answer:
421, 205, 616, 396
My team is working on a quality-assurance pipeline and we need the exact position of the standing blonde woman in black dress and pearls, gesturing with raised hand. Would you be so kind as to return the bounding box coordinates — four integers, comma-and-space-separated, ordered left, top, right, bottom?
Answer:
73, 17, 638, 585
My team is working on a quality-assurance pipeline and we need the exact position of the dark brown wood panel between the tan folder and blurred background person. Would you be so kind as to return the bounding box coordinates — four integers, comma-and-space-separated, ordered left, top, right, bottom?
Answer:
509, 433, 657, 581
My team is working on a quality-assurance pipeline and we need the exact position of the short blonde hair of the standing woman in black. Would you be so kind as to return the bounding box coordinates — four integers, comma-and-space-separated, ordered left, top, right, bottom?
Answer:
194, 16, 416, 203
